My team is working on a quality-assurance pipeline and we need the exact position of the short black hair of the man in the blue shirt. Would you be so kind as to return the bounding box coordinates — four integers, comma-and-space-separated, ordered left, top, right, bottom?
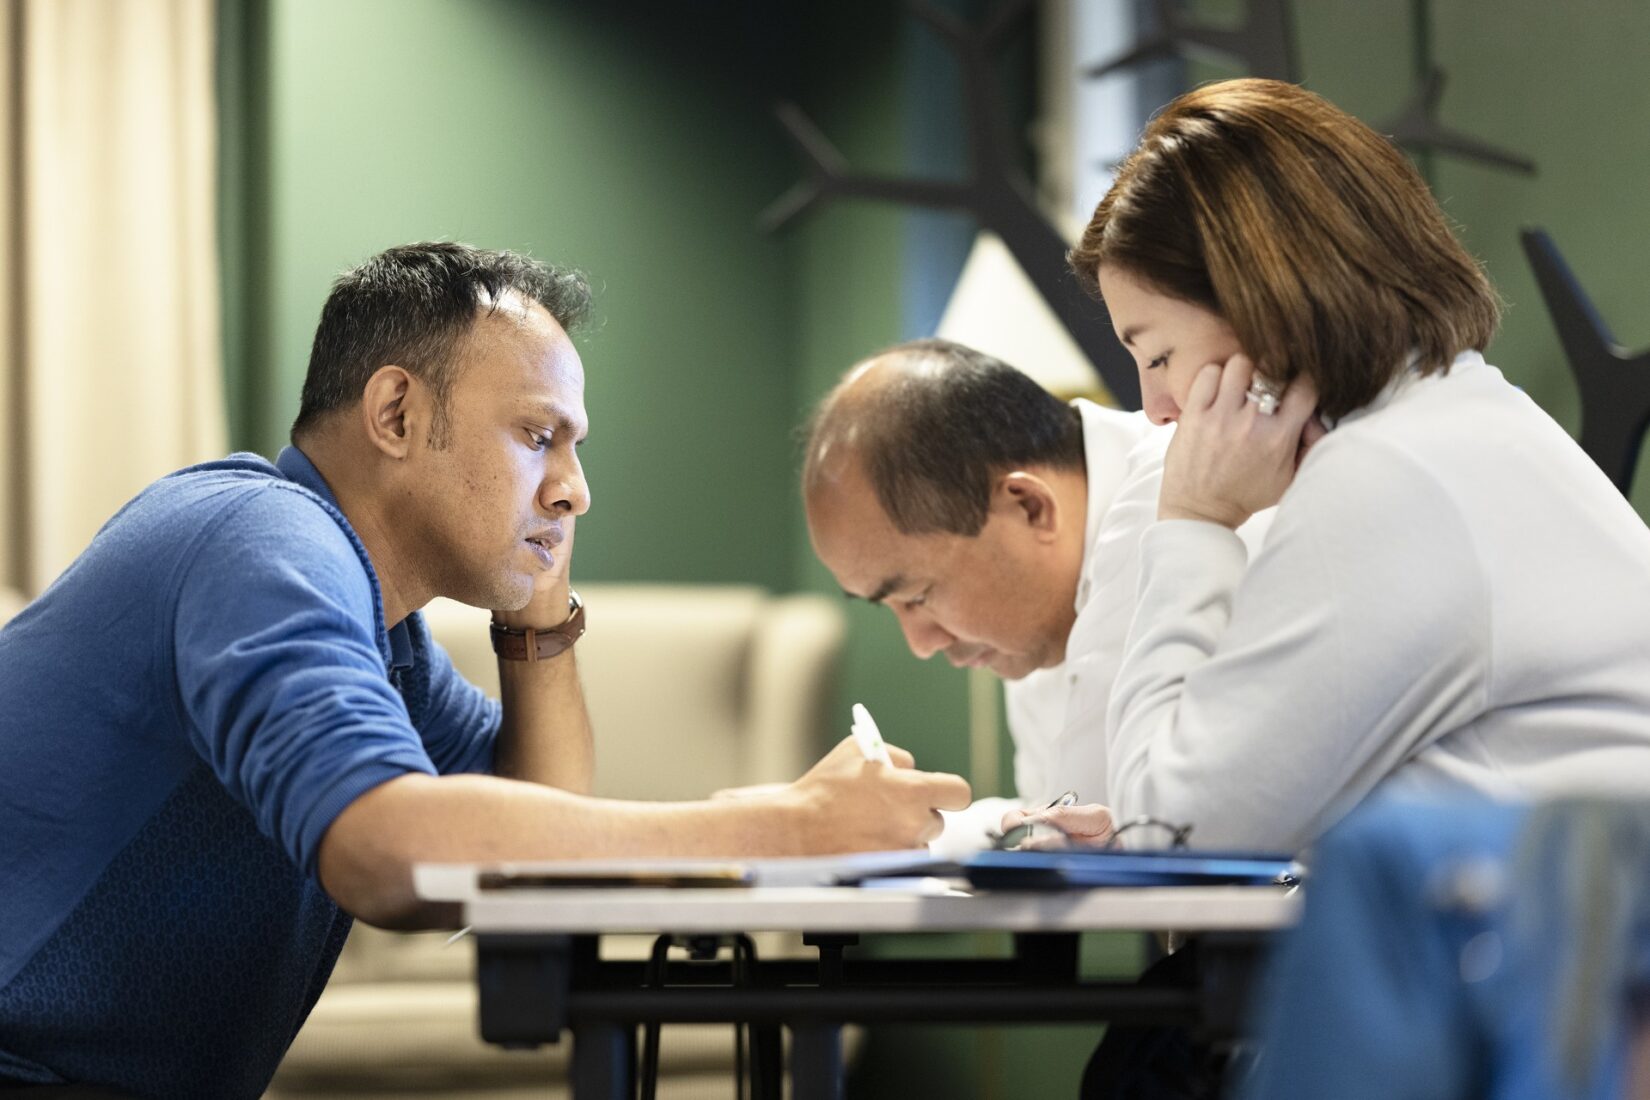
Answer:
292, 241, 591, 447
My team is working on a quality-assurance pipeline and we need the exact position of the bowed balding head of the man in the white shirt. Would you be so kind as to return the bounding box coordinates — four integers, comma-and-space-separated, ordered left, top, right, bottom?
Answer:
804, 340, 1087, 679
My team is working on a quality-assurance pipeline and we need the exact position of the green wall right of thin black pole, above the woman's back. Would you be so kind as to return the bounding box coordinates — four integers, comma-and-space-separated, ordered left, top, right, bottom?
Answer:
1432, 0, 1650, 507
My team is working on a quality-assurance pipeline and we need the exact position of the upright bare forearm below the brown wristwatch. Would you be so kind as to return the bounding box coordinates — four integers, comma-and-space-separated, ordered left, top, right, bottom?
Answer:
493, 646, 596, 795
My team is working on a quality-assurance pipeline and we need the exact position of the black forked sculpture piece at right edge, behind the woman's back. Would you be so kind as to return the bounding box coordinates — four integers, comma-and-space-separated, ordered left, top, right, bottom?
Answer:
1518, 229, 1650, 493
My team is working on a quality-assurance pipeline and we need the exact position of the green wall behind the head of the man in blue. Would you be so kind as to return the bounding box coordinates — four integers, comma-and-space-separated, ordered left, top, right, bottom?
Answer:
224, 0, 797, 589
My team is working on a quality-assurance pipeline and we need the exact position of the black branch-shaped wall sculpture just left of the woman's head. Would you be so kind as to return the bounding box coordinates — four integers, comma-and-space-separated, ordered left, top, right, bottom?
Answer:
762, 0, 1140, 409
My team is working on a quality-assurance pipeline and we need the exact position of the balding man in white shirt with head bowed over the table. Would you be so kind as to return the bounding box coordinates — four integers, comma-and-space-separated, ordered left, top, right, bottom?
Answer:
804, 340, 1271, 853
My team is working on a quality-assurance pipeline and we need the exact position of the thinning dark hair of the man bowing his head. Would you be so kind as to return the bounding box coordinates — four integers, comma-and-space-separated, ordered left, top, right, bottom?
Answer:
804, 340, 1084, 538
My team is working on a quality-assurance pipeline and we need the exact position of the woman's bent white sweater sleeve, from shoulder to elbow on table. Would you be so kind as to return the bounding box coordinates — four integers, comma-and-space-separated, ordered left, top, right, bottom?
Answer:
1107, 440, 1490, 851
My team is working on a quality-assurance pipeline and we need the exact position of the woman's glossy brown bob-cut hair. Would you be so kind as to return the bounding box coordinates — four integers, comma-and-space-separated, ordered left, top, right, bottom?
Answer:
1068, 79, 1500, 417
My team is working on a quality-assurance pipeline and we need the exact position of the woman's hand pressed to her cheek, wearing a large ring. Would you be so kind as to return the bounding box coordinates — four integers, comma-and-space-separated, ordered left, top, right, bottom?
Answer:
1157, 355, 1318, 528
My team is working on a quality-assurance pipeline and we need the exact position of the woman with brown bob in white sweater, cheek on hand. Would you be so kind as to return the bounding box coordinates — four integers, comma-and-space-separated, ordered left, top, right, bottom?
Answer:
1054, 79, 1650, 851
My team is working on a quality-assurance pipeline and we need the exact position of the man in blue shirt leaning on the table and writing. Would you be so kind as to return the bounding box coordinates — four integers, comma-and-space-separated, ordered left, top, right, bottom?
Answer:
0, 244, 969, 1097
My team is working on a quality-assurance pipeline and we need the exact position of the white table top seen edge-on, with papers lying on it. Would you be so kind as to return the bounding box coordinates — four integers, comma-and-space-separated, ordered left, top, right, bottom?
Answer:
414, 864, 1300, 933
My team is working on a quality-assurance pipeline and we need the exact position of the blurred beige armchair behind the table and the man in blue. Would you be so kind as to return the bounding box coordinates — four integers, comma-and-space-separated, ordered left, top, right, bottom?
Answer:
267, 584, 846, 1100
